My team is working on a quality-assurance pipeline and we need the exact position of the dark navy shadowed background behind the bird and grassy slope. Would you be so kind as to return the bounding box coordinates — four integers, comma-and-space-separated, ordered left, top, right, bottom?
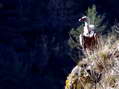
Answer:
0, 0, 119, 89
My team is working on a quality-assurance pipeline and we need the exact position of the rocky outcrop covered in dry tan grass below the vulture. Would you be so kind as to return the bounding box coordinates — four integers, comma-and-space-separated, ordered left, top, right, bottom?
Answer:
65, 35, 119, 89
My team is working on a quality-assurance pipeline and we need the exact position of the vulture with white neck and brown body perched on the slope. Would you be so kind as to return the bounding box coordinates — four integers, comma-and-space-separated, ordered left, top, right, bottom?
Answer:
79, 16, 98, 51
